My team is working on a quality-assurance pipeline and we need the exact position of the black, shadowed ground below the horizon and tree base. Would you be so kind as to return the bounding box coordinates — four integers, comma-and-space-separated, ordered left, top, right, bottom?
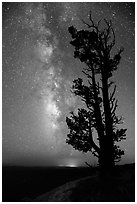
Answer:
2, 164, 135, 202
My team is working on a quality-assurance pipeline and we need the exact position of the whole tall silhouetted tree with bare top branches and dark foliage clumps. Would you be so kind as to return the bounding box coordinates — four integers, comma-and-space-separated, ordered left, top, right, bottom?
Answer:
66, 13, 127, 171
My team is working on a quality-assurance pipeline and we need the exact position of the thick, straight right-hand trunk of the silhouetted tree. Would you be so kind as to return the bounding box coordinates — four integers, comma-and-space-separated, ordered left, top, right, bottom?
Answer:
100, 63, 114, 171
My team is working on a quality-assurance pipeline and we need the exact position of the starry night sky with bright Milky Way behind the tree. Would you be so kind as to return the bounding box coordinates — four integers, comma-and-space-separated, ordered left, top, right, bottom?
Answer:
2, 2, 135, 166
